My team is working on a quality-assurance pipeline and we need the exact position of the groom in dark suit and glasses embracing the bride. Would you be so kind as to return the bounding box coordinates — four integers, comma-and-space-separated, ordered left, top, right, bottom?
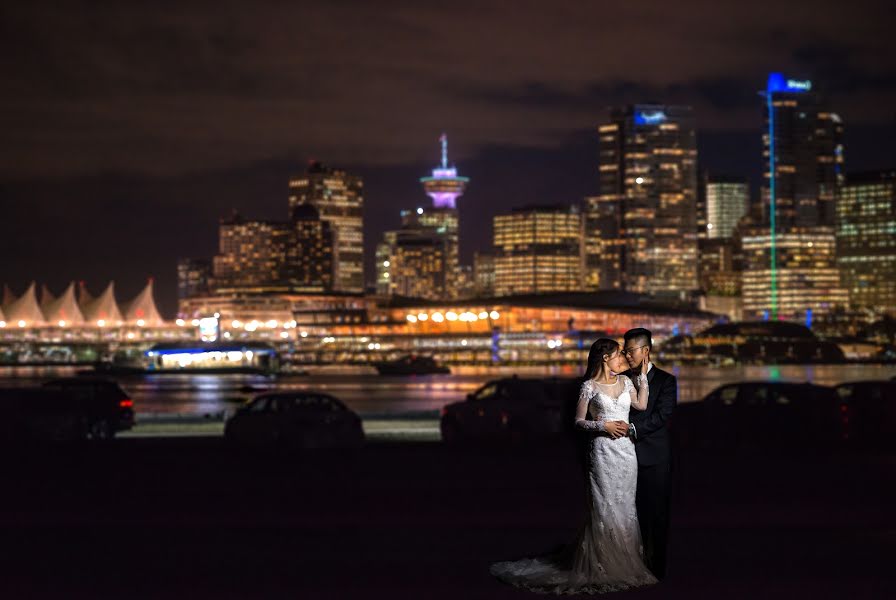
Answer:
623, 327, 678, 579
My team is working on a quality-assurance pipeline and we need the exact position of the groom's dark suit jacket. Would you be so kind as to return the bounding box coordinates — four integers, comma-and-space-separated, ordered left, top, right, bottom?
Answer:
625, 365, 678, 466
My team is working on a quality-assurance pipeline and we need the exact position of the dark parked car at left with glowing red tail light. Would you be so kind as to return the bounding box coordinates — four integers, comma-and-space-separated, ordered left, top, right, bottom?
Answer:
44, 377, 135, 440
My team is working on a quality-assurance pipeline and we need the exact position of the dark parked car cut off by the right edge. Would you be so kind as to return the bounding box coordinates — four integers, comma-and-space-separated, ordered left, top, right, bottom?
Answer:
834, 380, 896, 447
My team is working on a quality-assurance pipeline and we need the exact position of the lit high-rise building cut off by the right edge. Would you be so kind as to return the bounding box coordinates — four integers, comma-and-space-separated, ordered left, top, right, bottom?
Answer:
837, 170, 896, 316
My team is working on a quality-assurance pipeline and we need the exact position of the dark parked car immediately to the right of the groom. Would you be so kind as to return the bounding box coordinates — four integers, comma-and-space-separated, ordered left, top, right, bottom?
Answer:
670, 381, 844, 448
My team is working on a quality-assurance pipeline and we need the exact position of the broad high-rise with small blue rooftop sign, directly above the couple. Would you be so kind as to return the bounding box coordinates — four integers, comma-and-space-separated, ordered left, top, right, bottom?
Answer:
584, 104, 697, 297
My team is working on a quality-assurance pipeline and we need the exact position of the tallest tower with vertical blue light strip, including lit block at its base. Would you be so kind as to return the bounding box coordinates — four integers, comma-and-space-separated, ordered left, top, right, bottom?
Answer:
743, 73, 847, 322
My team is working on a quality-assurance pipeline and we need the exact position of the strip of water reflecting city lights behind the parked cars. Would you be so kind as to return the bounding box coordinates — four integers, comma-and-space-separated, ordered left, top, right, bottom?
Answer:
0, 365, 896, 416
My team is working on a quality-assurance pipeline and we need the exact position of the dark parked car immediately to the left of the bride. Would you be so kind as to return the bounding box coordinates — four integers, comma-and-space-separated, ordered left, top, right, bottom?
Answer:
440, 377, 579, 443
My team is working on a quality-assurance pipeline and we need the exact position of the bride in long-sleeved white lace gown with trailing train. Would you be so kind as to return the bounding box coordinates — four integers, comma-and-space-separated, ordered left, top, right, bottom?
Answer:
490, 338, 657, 594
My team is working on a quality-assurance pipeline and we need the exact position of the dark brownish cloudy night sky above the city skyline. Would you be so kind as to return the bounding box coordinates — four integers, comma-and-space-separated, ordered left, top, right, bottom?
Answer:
0, 0, 896, 317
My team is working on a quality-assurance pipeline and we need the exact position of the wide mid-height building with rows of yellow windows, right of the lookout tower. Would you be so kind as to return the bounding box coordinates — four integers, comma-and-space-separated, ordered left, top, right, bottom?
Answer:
494, 205, 582, 296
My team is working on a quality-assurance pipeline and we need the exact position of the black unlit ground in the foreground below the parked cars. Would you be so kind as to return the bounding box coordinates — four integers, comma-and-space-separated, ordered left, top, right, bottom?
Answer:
0, 438, 896, 600
